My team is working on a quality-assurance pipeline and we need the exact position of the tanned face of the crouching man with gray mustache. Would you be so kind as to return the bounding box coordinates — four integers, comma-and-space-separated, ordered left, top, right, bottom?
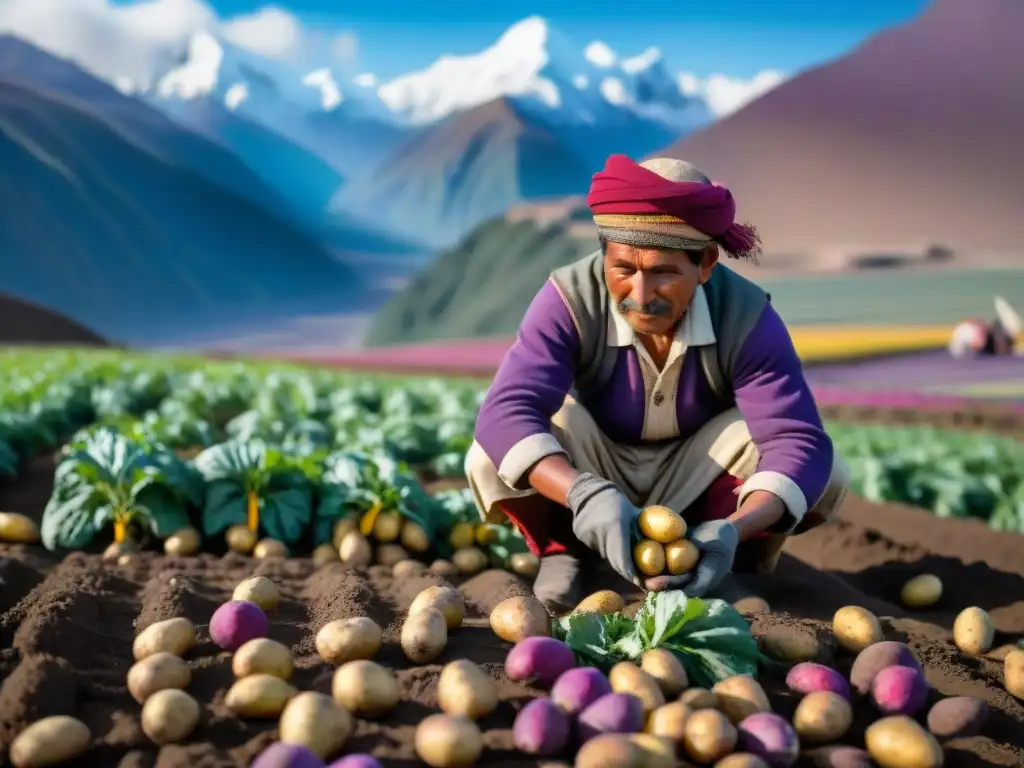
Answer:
604, 243, 718, 335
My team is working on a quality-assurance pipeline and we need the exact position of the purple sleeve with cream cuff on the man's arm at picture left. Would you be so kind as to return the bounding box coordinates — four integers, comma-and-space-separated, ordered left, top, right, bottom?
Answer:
474, 281, 580, 488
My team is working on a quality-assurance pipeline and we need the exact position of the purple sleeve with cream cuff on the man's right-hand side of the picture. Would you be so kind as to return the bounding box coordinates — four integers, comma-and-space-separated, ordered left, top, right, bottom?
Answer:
733, 304, 834, 531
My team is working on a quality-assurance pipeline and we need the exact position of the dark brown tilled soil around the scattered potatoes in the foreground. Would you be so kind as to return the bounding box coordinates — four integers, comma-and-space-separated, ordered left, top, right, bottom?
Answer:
0, 460, 1024, 768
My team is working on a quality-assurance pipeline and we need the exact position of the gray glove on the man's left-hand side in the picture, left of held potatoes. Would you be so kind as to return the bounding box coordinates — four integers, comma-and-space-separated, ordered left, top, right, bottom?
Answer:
566, 472, 640, 586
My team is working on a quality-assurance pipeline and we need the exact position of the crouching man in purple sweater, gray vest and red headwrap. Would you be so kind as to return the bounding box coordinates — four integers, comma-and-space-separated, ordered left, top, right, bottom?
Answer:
466, 155, 849, 612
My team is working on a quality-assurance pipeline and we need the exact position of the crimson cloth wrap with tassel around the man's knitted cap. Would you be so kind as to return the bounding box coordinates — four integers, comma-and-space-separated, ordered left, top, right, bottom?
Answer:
587, 155, 761, 258
